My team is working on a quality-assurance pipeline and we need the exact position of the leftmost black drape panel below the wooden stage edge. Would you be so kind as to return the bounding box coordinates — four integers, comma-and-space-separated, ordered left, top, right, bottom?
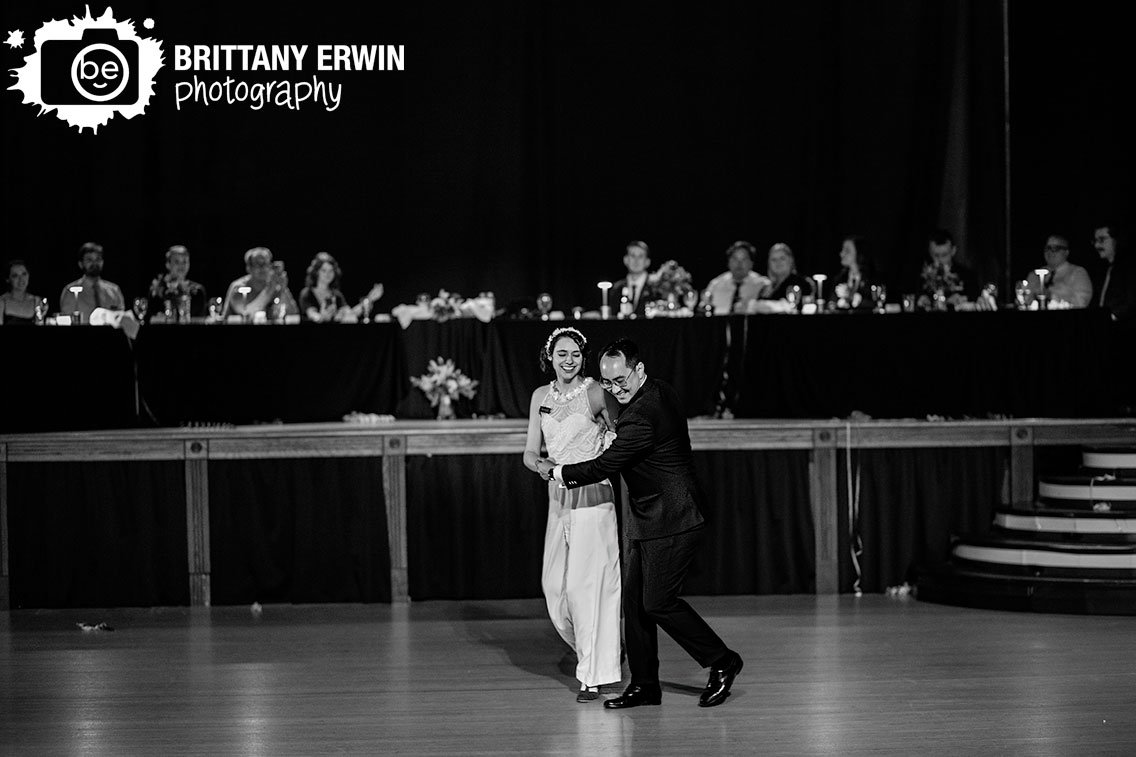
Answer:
8, 461, 190, 604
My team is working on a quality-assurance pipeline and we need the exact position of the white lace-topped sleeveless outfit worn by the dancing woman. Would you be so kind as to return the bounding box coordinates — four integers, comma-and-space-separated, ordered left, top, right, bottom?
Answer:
541, 379, 623, 687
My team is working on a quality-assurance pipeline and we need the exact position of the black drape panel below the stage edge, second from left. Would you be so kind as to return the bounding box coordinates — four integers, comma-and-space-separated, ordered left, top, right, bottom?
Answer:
209, 458, 391, 605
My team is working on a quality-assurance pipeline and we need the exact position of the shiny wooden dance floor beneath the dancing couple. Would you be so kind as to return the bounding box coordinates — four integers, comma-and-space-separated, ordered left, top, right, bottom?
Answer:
0, 594, 1136, 756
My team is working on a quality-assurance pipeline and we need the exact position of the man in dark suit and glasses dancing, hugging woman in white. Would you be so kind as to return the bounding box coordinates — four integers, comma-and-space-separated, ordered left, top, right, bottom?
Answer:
537, 338, 742, 709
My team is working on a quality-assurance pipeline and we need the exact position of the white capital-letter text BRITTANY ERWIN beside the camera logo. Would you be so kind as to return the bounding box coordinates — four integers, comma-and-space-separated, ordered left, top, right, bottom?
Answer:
174, 44, 406, 70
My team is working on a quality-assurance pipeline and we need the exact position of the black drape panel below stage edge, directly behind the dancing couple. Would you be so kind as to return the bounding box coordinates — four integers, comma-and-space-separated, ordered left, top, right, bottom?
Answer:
407, 451, 816, 599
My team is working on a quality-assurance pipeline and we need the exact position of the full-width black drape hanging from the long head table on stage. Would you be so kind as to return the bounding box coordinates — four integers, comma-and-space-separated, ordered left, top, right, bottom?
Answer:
0, 309, 1136, 432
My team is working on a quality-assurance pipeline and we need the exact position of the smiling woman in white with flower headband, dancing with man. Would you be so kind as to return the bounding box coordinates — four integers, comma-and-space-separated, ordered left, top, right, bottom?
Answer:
524, 326, 623, 702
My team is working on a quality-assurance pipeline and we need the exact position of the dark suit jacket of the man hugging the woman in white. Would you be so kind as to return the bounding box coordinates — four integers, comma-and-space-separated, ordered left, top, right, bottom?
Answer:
560, 376, 703, 540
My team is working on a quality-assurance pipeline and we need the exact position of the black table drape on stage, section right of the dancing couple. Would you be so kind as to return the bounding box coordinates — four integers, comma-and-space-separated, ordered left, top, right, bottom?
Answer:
734, 310, 1117, 418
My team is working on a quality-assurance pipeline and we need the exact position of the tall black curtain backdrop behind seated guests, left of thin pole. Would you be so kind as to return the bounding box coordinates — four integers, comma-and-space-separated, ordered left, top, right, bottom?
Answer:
0, 0, 1054, 318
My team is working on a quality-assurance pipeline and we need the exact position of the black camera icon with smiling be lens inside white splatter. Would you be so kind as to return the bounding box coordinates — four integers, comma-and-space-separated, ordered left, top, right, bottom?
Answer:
40, 28, 139, 105
